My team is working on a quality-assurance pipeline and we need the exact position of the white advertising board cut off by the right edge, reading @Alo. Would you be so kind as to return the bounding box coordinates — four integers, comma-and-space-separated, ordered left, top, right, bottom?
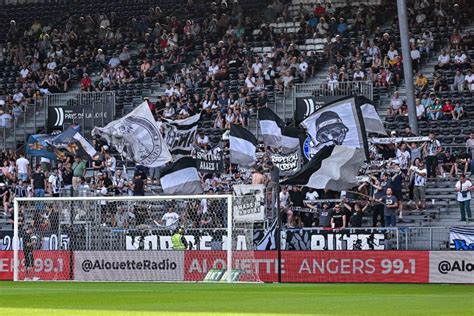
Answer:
429, 251, 474, 283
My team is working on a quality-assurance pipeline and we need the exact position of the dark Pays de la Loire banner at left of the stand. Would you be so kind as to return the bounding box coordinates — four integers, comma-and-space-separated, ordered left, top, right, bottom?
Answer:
47, 102, 114, 132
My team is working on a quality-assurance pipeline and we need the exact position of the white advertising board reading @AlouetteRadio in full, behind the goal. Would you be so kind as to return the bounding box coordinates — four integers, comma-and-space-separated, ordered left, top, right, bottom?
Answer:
74, 251, 184, 281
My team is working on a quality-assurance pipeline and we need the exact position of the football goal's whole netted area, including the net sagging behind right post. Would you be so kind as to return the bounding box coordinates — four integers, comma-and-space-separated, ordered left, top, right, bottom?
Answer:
13, 195, 260, 282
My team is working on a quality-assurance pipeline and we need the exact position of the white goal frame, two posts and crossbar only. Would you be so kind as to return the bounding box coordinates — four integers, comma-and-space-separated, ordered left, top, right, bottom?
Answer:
12, 194, 233, 283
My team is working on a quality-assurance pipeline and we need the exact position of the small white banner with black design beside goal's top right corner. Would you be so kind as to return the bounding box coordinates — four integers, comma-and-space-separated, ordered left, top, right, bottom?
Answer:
233, 184, 265, 222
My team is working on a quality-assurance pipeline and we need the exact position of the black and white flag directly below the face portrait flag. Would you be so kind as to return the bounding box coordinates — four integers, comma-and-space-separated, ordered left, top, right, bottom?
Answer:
282, 145, 365, 191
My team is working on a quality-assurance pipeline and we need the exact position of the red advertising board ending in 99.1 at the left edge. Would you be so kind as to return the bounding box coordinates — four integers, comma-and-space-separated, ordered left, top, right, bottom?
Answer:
0, 250, 71, 280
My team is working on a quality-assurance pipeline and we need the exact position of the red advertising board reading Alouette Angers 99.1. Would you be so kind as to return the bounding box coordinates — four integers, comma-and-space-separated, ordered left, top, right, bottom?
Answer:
184, 251, 429, 283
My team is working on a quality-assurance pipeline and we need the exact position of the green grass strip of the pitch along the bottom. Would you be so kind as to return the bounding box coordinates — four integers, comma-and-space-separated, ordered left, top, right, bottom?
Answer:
0, 282, 474, 316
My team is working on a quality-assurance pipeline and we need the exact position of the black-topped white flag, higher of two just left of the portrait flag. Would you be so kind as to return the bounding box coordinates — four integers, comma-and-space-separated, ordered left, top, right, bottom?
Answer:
258, 108, 285, 148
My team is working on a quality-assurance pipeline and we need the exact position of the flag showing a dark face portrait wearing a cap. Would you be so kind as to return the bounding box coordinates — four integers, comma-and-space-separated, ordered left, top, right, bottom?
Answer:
300, 97, 367, 156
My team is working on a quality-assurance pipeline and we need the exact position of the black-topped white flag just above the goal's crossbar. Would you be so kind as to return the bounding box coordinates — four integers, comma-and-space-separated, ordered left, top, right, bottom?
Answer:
160, 157, 204, 195
